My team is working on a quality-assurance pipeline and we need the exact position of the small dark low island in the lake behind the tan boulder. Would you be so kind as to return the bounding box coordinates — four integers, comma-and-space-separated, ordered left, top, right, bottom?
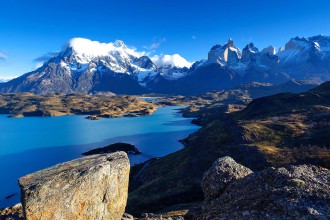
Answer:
82, 143, 141, 156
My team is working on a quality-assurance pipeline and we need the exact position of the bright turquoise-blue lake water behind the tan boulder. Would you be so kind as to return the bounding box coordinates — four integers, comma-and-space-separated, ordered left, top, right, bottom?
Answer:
0, 107, 199, 208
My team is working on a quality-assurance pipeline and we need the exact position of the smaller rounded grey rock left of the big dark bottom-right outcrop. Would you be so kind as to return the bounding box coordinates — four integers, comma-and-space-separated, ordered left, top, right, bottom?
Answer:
202, 157, 252, 199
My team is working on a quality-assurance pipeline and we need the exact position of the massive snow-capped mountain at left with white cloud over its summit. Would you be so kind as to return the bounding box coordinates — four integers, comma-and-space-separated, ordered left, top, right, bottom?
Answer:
0, 38, 186, 94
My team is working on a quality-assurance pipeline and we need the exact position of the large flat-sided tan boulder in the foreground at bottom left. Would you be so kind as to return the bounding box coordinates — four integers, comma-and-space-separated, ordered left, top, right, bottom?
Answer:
19, 152, 130, 220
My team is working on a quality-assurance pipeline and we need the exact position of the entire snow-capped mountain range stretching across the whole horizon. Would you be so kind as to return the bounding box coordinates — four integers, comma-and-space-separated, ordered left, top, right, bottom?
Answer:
0, 35, 330, 95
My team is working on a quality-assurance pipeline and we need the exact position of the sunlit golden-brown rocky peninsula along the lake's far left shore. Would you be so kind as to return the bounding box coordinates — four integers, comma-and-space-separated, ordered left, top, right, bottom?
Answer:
0, 93, 157, 120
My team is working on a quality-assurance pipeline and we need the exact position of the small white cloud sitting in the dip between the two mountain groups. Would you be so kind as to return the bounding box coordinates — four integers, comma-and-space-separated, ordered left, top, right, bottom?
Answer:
150, 54, 192, 67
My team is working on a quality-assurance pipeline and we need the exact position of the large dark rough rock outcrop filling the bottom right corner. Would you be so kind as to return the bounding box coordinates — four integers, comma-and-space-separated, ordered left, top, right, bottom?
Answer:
199, 159, 330, 219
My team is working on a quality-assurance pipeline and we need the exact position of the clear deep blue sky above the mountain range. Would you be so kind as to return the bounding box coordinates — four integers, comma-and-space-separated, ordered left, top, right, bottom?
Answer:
0, 0, 330, 78
